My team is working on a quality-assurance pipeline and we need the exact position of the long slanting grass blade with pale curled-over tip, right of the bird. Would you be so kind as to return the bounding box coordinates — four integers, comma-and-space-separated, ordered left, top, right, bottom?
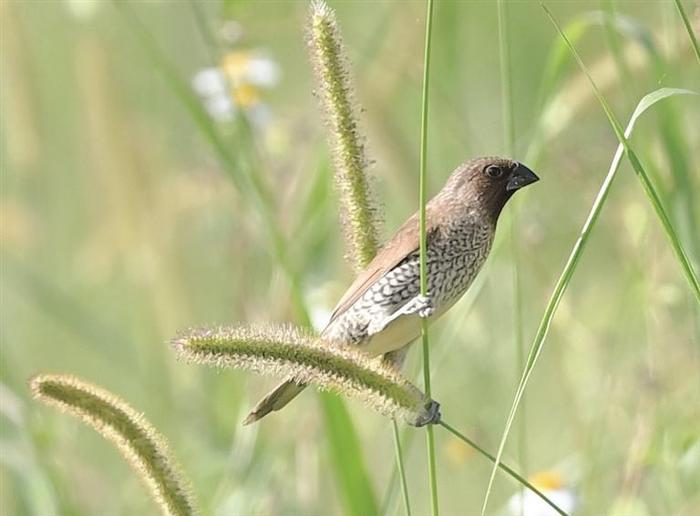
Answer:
482, 76, 692, 515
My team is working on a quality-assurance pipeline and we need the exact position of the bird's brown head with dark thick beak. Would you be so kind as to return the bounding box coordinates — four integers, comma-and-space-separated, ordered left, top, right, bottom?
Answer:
436, 156, 539, 223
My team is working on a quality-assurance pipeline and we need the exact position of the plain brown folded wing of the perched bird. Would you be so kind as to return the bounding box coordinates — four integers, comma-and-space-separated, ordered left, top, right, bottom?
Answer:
328, 209, 436, 326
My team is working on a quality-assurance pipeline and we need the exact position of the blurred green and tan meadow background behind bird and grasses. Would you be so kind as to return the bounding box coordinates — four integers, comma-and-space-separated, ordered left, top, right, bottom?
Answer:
0, 0, 700, 516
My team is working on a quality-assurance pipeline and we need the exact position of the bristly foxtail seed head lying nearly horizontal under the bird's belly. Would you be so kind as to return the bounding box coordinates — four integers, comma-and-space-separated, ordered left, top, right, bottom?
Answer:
172, 325, 439, 426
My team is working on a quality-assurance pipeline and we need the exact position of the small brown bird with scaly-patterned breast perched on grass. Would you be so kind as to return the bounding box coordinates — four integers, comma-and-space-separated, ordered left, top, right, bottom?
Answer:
244, 157, 539, 425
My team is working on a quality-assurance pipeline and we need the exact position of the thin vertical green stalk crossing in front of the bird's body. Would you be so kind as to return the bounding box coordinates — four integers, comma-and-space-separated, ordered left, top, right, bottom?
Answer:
419, 0, 440, 516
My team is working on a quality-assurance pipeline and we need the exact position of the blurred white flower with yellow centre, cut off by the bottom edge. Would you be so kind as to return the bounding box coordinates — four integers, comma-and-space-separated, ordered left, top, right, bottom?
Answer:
506, 471, 576, 516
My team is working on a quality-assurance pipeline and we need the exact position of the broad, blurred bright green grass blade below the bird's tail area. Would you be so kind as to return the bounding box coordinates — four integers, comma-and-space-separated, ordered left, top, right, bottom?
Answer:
321, 393, 378, 516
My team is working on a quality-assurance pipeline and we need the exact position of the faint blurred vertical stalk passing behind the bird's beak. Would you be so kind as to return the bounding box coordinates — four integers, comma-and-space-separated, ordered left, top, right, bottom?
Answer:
497, 0, 527, 515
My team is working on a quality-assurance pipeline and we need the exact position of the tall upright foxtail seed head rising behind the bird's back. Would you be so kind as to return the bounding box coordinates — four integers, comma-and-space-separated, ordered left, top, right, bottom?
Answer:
307, 1, 379, 271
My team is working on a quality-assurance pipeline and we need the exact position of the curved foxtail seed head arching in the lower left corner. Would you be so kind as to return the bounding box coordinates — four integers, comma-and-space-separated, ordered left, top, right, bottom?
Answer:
29, 374, 197, 516
